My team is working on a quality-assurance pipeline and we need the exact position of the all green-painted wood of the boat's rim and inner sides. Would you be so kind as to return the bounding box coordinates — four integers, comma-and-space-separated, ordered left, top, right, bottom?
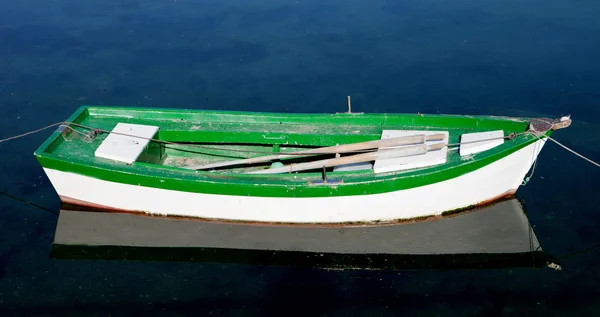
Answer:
35, 106, 548, 197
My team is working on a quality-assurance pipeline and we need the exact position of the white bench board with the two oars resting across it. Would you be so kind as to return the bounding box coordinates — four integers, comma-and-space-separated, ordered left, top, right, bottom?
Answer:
373, 130, 448, 173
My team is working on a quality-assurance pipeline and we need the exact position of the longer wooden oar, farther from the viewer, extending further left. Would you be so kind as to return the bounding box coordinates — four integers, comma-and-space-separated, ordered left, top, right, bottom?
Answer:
183, 134, 444, 170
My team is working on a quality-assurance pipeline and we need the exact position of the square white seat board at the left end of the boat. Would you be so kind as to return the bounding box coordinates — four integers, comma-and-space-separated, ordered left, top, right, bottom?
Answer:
94, 123, 158, 164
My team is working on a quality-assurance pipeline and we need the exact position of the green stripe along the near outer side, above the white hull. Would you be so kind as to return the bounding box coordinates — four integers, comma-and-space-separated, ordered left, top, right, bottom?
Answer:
39, 140, 535, 197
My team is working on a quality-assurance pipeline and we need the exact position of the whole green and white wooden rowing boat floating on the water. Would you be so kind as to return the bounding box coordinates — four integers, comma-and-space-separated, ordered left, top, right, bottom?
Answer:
35, 106, 571, 225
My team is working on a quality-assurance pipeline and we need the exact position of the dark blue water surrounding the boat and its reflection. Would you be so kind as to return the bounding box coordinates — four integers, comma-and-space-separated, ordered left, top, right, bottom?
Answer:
0, 0, 600, 316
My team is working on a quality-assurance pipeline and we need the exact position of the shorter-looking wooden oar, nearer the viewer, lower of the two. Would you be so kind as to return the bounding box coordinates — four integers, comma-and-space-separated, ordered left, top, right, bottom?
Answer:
245, 143, 446, 174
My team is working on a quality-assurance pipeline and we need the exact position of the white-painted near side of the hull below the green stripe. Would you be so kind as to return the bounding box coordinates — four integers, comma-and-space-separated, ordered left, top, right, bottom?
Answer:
44, 139, 546, 223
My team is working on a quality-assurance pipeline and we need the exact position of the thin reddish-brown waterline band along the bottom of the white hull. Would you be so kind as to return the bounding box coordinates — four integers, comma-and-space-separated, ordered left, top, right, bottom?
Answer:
60, 189, 516, 228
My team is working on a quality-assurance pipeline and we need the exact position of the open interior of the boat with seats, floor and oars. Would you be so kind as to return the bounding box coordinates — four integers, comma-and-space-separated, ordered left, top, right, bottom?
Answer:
44, 107, 531, 175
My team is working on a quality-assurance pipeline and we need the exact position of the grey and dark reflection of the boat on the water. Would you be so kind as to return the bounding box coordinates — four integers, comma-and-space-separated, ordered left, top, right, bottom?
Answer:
51, 198, 555, 270
